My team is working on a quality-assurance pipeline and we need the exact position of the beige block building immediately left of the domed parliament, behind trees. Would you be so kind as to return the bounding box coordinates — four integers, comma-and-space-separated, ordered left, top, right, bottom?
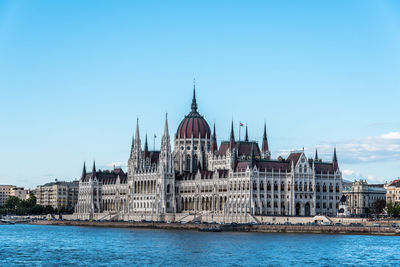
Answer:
35, 180, 79, 210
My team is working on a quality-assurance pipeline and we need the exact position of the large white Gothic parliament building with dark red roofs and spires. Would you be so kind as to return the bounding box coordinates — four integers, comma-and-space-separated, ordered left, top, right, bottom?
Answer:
75, 89, 342, 222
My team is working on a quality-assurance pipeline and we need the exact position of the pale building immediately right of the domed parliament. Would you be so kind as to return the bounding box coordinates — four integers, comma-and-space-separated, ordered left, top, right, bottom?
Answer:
343, 180, 386, 216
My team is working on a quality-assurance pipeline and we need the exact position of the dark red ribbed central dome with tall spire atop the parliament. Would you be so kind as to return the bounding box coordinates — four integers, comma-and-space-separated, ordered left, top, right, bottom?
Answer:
176, 89, 211, 139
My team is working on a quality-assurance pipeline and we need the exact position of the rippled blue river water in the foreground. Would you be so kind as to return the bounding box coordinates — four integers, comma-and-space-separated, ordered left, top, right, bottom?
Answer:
0, 225, 400, 266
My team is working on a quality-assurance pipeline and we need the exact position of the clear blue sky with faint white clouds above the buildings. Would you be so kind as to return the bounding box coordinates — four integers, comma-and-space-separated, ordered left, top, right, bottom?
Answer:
0, 0, 400, 187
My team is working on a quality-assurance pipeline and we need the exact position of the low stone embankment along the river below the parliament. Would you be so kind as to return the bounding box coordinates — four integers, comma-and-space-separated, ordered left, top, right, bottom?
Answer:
28, 221, 400, 236
